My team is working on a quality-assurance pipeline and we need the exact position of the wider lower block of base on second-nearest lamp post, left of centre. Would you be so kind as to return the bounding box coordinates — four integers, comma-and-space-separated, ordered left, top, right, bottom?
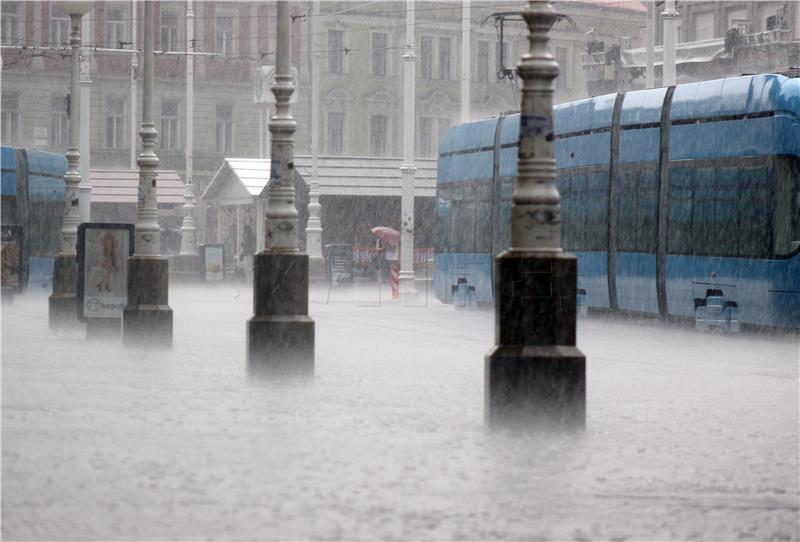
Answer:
247, 314, 314, 377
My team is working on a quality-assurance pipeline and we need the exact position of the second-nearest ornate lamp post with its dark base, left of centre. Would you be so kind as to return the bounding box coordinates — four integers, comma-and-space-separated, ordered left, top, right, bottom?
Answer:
247, 1, 314, 377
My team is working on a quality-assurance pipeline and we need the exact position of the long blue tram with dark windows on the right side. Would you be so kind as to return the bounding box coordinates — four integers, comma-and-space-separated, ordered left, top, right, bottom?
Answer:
435, 75, 800, 330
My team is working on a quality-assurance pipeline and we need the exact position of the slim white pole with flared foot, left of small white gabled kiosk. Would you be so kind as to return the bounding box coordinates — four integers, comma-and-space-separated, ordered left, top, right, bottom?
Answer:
181, 0, 197, 256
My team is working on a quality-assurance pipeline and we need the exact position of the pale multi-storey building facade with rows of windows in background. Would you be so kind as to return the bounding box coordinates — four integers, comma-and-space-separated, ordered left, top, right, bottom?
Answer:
2, 0, 644, 248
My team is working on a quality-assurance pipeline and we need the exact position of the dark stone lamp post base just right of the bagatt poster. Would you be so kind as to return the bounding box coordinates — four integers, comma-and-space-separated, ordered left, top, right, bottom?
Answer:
122, 256, 172, 348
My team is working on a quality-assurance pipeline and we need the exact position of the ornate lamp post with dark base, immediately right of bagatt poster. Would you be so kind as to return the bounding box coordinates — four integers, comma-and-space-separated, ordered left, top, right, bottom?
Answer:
122, 0, 172, 347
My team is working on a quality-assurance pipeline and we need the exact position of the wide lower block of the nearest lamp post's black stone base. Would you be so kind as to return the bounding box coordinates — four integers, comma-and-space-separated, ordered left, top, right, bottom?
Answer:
485, 346, 586, 430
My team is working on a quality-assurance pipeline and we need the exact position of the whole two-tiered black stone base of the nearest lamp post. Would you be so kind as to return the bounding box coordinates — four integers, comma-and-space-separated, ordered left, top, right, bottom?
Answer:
485, 250, 586, 429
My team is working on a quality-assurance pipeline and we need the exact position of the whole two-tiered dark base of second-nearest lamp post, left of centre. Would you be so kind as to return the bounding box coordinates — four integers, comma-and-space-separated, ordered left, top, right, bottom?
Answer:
247, 251, 314, 377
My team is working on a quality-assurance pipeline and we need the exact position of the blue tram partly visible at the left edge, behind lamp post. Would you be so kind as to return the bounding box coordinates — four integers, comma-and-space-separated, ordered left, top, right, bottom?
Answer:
0, 147, 67, 292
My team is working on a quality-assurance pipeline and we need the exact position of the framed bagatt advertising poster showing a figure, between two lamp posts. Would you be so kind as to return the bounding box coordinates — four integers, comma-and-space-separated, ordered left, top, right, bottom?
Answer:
78, 223, 133, 318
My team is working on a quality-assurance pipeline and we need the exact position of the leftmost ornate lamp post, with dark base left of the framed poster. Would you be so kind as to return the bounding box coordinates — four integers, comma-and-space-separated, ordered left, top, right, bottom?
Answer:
48, 2, 92, 327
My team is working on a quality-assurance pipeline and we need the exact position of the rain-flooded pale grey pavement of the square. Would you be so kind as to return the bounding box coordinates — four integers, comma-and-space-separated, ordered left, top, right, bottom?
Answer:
2, 286, 800, 540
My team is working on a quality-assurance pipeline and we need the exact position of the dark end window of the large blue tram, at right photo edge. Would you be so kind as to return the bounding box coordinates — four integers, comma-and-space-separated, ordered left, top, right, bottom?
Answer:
773, 158, 800, 256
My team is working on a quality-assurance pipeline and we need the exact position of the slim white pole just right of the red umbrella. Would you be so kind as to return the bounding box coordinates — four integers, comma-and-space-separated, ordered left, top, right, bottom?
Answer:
399, 0, 417, 301
